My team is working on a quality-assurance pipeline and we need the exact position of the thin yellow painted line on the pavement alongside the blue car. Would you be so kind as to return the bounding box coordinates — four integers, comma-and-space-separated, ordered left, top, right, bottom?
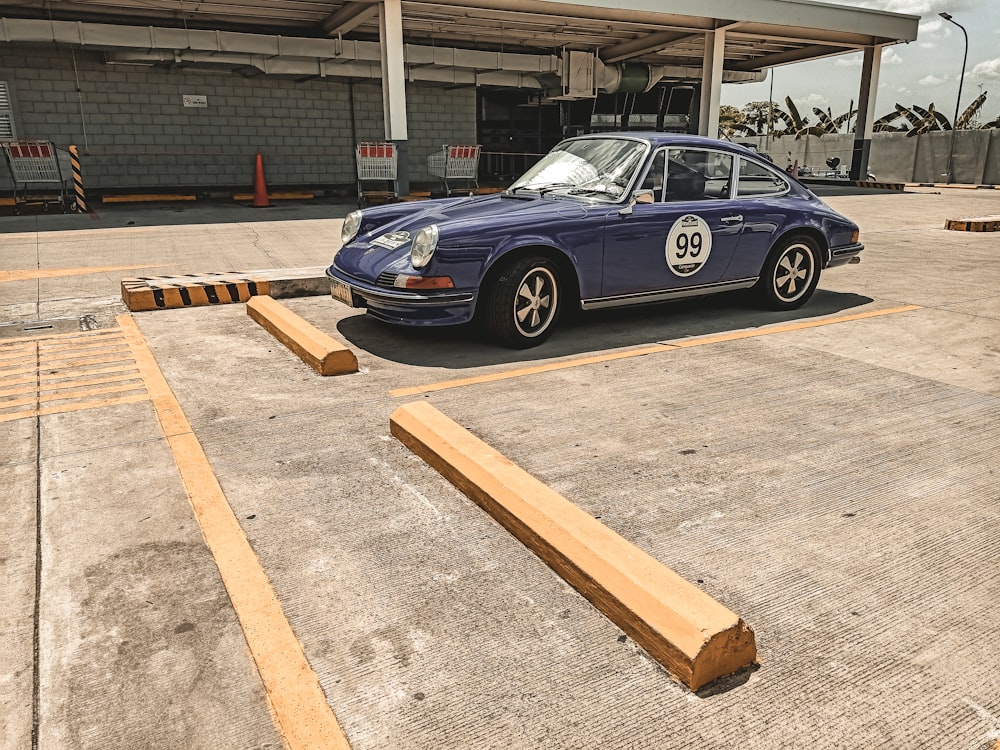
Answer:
389, 305, 921, 398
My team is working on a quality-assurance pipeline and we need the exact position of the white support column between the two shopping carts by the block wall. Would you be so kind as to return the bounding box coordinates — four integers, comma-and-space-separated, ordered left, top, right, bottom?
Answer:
378, 0, 410, 195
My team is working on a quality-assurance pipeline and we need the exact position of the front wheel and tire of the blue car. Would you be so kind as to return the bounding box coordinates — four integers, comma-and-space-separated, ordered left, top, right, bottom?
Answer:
483, 256, 562, 349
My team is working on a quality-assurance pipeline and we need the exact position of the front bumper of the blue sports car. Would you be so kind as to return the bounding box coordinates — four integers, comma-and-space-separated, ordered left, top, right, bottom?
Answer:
326, 263, 476, 326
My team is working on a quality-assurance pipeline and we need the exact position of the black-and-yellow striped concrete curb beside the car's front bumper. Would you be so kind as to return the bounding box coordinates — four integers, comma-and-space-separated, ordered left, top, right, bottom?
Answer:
122, 267, 330, 312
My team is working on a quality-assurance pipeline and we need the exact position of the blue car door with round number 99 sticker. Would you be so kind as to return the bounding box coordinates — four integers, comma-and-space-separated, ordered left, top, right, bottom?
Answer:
601, 148, 743, 299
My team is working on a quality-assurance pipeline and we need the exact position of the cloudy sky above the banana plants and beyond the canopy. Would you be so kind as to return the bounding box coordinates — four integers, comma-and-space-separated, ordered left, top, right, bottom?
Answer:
722, 0, 1000, 122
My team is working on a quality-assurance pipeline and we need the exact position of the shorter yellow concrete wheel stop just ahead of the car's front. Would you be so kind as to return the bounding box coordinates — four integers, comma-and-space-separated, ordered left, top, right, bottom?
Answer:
247, 296, 358, 375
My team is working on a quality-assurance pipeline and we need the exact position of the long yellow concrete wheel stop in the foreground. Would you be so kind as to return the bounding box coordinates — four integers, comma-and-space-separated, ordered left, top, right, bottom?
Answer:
390, 402, 757, 690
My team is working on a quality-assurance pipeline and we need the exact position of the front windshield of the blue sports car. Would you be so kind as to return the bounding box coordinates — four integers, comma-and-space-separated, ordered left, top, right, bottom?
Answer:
508, 138, 648, 200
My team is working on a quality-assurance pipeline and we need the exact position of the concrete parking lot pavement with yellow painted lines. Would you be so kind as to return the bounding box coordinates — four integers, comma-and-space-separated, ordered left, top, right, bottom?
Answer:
0, 190, 1000, 750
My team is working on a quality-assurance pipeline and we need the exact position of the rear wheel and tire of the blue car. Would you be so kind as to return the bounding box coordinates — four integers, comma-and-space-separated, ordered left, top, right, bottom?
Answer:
753, 235, 822, 310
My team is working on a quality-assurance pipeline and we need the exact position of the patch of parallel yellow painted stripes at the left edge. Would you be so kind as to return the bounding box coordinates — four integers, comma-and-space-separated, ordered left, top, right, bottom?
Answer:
0, 331, 149, 422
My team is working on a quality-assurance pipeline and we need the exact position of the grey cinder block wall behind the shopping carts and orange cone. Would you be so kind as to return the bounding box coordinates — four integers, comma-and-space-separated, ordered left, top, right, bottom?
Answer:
0, 44, 476, 191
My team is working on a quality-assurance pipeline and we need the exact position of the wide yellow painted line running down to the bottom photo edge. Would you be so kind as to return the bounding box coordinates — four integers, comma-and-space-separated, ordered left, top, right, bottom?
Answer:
118, 315, 350, 750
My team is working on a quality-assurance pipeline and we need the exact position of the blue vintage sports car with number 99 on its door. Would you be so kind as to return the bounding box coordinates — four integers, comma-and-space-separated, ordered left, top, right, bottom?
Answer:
326, 133, 864, 348
